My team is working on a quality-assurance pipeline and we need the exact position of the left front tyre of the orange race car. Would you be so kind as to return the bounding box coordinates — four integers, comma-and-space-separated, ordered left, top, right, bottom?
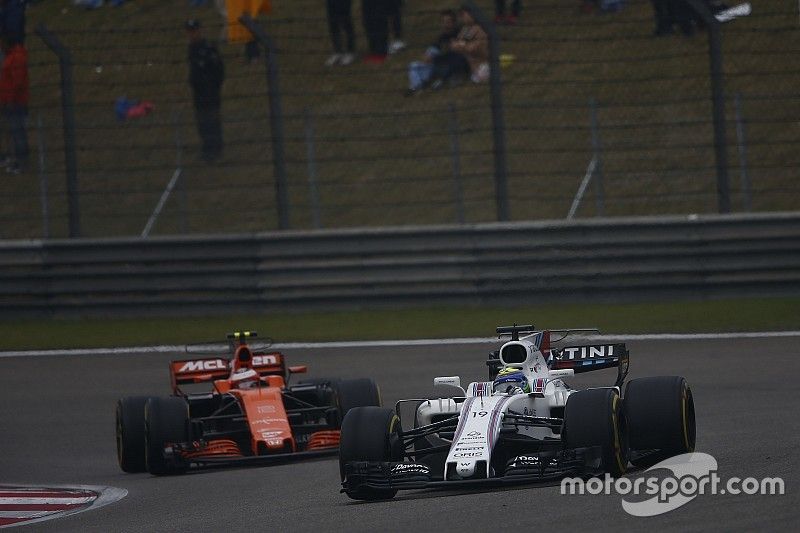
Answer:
144, 396, 189, 476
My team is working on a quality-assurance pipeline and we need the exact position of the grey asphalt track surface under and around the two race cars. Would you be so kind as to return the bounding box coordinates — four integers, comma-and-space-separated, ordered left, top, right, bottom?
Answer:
0, 337, 800, 532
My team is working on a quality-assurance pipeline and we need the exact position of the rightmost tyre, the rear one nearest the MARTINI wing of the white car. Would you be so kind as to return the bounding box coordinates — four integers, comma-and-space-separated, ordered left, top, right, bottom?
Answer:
623, 376, 697, 467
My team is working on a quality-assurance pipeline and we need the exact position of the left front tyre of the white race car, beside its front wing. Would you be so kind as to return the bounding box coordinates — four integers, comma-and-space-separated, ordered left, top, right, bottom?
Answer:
339, 406, 403, 500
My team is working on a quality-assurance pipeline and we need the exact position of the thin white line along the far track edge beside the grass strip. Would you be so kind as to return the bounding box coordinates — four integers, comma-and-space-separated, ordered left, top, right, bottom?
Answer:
0, 331, 800, 358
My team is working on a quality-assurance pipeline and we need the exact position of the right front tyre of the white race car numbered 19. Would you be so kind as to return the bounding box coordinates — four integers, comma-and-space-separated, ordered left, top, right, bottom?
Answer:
562, 389, 628, 477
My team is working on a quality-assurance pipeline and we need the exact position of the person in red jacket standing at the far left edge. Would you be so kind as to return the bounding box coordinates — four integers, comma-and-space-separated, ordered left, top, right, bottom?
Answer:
0, 35, 30, 174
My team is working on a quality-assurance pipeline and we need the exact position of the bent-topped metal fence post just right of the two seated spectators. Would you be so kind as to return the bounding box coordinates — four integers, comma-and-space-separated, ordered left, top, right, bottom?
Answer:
464, 0, 511, 222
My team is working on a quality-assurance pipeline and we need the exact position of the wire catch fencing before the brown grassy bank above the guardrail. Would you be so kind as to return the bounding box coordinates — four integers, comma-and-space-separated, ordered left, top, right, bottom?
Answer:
6, 0, 800, 239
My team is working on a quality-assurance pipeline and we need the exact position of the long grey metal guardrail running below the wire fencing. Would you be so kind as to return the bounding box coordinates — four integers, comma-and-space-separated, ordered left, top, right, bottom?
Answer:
0, 213, 800, 318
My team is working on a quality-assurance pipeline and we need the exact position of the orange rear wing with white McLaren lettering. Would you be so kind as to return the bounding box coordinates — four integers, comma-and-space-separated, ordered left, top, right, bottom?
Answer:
169, 352, 286, 394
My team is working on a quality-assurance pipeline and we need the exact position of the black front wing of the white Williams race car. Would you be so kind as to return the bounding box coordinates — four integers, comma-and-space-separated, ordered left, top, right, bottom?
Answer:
341, 446, 603, 492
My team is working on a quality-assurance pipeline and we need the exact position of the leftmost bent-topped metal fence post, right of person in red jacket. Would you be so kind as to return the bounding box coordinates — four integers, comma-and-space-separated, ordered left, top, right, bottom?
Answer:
35, 24, 81, 238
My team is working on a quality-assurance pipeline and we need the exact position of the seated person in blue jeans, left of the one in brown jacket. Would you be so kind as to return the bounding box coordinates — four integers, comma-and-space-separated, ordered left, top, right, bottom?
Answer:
406, 9, 469, 96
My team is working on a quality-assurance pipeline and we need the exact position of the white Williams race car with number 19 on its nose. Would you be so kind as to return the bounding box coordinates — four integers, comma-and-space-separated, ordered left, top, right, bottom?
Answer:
339, 325, 695, 500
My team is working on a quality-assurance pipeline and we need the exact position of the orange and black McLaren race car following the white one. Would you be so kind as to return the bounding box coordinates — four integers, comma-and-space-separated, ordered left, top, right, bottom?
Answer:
116, 331, 380, 475
